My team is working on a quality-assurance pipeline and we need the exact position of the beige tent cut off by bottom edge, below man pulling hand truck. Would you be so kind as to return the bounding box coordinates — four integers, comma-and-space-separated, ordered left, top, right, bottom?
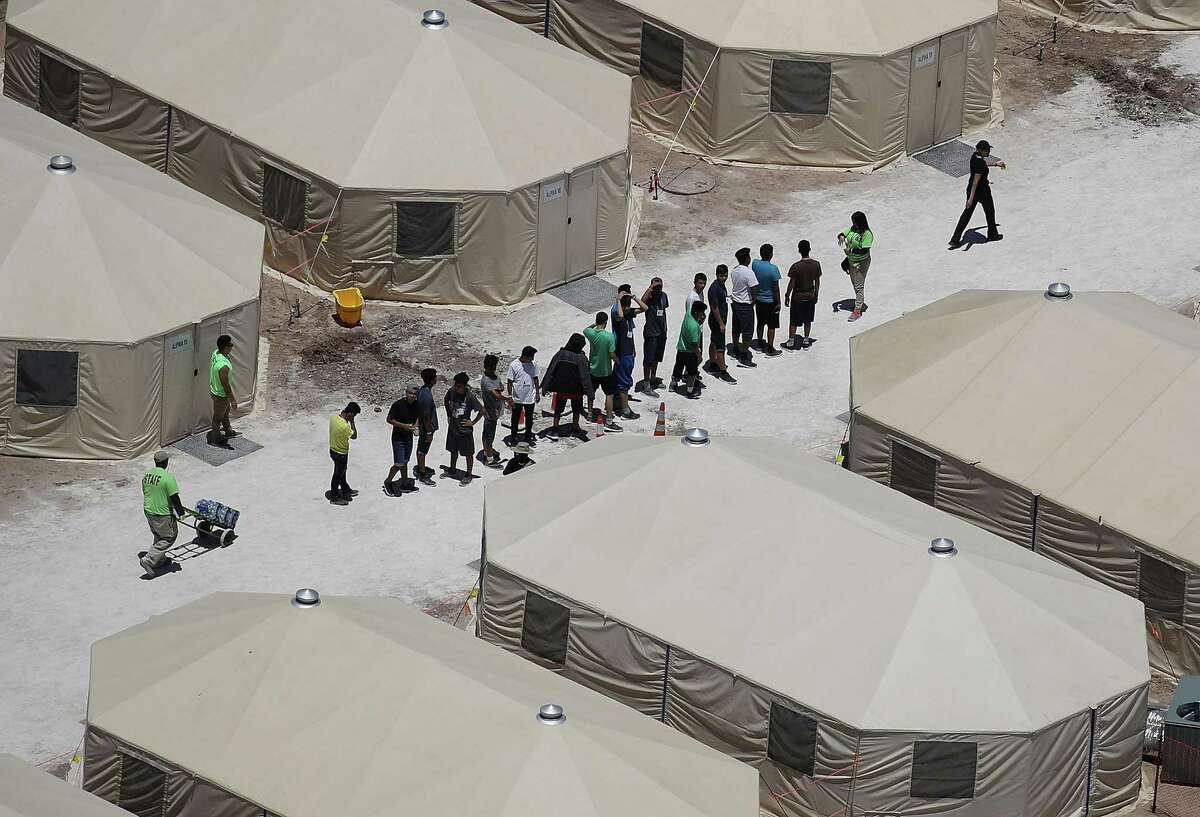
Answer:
84, 590, 757, 817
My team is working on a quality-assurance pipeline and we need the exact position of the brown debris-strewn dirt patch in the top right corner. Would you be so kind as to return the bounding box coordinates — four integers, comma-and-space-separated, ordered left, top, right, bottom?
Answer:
996, 1, 1200, 126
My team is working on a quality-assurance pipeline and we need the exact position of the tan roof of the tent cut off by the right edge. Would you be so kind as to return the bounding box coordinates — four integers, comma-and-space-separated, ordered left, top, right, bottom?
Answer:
851, 292, 1200, 563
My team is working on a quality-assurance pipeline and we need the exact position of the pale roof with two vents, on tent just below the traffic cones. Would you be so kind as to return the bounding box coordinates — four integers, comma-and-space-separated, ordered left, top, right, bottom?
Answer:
486, 435, 1148, 732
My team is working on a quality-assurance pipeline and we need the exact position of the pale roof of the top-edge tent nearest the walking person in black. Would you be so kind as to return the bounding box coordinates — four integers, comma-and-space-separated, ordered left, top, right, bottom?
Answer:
595, 0, 997, 56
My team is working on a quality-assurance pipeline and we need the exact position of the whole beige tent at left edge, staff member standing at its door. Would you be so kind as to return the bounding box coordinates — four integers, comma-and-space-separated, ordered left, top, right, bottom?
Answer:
0, 100, 263, 459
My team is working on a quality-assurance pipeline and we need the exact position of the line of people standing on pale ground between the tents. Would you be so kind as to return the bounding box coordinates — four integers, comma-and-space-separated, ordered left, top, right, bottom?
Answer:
325, 212, 875, 505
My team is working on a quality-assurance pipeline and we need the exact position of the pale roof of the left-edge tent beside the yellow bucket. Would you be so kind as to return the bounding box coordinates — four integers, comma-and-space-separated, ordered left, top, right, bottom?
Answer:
0, 98, 263, 343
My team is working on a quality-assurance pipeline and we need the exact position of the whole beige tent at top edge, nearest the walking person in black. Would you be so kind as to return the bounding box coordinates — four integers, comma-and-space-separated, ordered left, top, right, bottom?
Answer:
475, 0, 997, 169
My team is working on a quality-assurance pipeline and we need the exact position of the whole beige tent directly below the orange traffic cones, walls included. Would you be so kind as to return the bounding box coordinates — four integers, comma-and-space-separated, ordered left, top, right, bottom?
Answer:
479, 434, 1150, 817
